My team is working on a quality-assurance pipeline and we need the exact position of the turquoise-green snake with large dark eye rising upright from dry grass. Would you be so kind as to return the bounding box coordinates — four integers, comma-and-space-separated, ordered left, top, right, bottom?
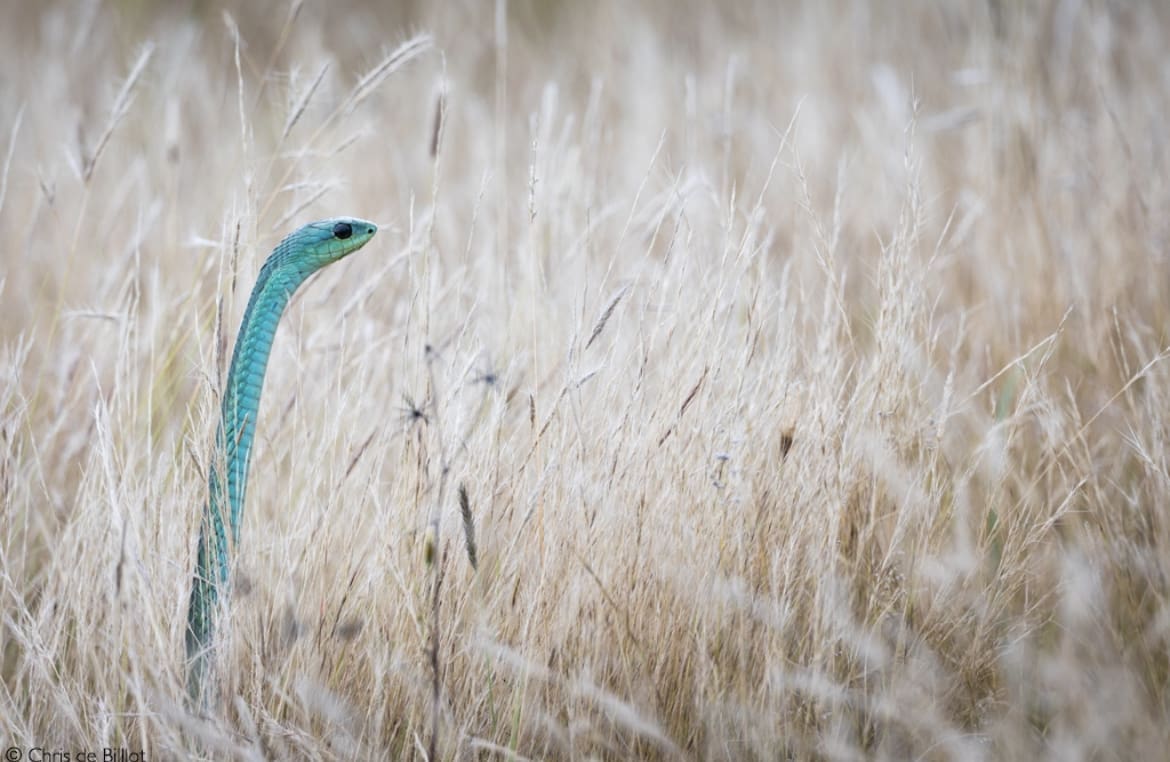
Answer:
186, 217, 378, 708
